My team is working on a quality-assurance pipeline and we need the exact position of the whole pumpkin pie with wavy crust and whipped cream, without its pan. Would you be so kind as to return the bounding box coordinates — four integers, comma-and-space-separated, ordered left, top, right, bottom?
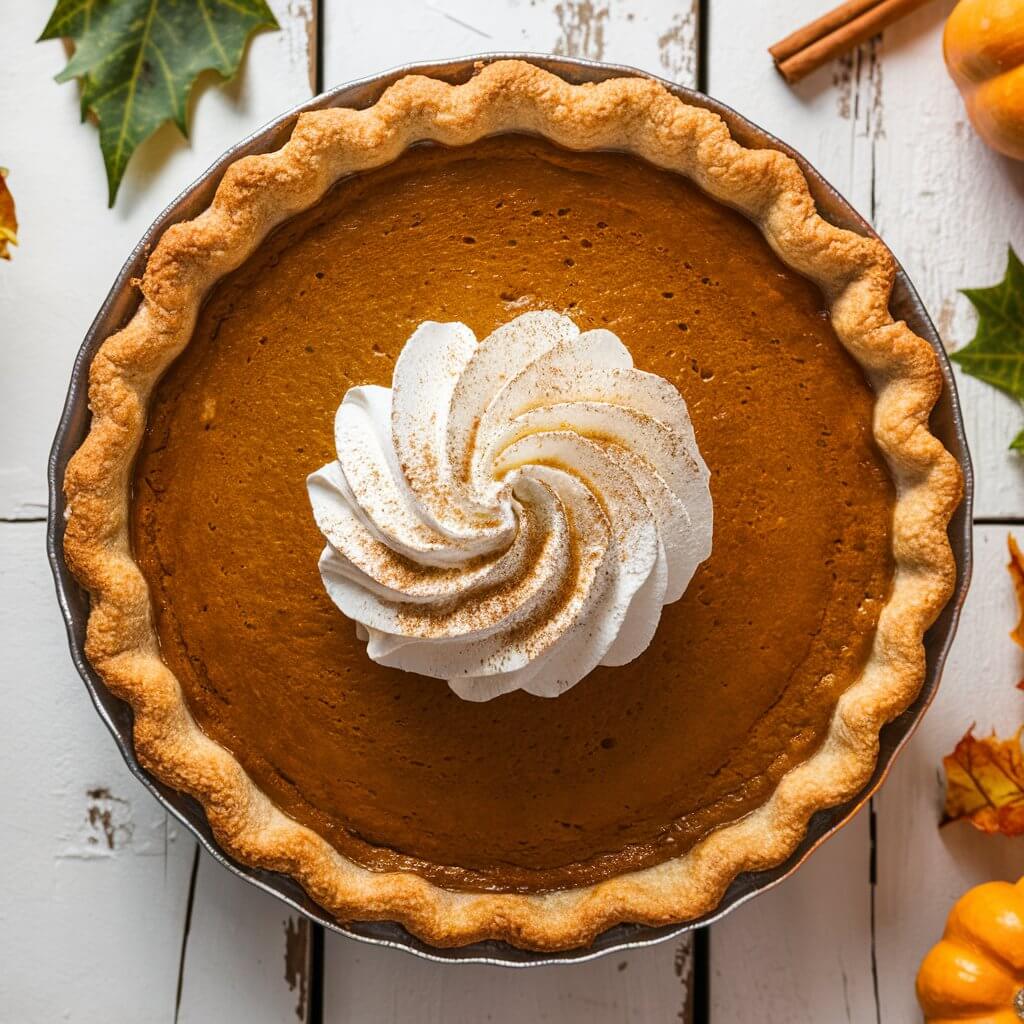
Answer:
65, 61, 962, 949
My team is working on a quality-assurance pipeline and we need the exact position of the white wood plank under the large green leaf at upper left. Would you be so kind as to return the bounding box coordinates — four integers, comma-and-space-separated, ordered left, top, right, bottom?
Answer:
0, 0, 313, 518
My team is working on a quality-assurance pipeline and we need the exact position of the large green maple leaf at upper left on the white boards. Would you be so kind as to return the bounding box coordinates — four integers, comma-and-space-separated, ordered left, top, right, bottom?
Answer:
39, 0, 278, 206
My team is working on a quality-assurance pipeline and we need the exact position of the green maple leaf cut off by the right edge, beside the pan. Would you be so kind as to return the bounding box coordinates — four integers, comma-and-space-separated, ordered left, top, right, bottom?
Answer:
950, 246, 1024, 452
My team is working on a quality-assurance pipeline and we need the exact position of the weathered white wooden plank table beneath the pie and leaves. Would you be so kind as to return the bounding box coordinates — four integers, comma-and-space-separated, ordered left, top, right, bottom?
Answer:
0, 0, 1024, 1024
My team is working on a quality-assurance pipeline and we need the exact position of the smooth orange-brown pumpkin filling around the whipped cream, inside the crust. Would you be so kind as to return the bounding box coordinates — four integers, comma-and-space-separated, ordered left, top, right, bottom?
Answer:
132, 136, 894, 891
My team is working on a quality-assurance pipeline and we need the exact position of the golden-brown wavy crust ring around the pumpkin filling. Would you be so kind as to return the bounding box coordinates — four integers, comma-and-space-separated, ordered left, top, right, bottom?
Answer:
65, 60, 962, 949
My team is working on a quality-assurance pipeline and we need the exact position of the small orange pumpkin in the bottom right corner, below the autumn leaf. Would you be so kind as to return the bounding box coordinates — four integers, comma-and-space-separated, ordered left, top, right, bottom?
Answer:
918, 879, 1024, 1024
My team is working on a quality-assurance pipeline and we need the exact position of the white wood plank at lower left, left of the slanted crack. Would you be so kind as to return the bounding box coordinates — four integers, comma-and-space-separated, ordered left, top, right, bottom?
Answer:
0, 522, 193, 1024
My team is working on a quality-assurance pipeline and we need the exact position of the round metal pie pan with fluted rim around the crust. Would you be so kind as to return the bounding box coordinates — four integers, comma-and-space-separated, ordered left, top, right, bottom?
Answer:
46, 53, 973, 967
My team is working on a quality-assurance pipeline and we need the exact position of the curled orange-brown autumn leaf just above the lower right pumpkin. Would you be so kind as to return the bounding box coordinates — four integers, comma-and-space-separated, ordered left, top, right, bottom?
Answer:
942, 726, 1024, 836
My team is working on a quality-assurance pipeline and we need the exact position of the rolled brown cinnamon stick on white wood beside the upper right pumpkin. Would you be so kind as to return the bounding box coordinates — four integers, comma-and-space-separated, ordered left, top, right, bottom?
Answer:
768, 0, 926, 84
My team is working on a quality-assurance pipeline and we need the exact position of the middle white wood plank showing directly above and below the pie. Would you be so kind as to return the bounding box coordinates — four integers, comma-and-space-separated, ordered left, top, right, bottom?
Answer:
323, 0, 697, 1024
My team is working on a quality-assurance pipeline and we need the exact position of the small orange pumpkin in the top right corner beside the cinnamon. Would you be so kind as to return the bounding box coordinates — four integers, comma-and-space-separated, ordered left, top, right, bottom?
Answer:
942, 0, 1024, 160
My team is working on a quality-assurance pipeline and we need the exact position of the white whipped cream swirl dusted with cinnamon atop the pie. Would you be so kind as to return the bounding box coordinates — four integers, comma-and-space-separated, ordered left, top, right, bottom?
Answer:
308, 311, 712, 700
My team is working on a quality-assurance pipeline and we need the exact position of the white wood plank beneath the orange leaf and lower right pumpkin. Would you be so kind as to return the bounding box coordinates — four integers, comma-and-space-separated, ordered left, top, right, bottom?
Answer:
876, 526, 1024, 1021
